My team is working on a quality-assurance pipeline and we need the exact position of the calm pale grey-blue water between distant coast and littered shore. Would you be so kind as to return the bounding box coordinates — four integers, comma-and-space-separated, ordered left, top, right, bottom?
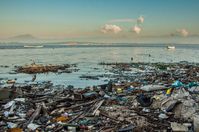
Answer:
0, 44, 199, 87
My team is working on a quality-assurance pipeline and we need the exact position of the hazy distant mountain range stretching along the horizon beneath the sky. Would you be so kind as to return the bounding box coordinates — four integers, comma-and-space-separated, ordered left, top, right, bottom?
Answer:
0, 34, 199, 45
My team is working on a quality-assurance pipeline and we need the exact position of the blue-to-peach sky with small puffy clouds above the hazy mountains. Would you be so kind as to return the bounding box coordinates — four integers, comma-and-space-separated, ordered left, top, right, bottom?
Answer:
0, 0, 199, 42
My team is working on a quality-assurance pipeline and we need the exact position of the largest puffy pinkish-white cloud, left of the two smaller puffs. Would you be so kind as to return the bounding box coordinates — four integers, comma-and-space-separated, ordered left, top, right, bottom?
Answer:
101, 24, 122, 34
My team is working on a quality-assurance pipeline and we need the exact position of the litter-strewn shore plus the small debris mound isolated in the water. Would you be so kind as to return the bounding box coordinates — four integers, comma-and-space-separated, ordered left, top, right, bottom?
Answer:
0, 62, 199, 132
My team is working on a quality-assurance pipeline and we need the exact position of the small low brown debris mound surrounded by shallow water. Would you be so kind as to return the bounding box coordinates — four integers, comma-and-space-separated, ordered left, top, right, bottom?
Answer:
15, 63, 78, 74
